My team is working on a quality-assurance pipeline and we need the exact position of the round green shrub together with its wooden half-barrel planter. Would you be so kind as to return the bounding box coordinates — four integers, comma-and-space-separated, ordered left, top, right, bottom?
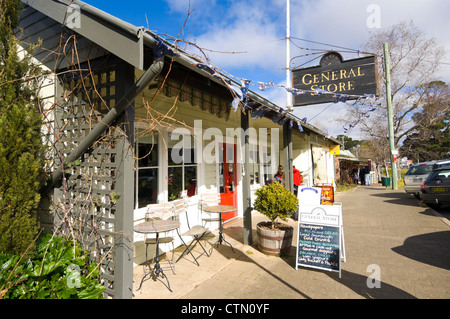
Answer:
253, 182, 298, 256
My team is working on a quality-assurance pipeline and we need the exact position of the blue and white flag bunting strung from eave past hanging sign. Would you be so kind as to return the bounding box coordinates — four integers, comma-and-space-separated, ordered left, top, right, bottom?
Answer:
153, 36, 381, 133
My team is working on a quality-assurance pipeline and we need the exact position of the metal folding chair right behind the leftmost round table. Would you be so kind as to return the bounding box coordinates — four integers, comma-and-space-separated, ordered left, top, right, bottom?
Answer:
145, 203, 176, 275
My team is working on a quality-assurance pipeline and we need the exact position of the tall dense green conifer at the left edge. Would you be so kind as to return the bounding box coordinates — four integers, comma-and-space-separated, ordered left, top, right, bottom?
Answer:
0, 0, 42, 254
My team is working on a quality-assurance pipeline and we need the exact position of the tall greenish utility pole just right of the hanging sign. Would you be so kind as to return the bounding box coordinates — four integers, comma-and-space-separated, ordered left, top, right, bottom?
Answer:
384, 43, 398, 190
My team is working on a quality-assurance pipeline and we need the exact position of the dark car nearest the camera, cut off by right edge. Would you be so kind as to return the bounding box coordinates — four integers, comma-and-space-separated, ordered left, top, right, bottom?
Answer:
420, 165, 450, 206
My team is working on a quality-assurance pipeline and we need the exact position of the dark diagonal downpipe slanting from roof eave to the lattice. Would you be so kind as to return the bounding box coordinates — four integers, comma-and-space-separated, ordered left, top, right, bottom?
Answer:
47, 47, 164, 189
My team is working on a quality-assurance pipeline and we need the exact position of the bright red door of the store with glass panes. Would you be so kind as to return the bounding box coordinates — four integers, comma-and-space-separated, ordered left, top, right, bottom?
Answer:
219, 143, 237, 220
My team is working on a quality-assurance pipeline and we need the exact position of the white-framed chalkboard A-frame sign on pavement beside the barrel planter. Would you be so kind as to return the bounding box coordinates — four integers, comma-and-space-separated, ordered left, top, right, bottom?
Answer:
296, 205, 343, 277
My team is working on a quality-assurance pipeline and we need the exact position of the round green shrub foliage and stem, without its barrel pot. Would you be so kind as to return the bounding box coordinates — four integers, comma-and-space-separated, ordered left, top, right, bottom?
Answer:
253, 182, 298, 229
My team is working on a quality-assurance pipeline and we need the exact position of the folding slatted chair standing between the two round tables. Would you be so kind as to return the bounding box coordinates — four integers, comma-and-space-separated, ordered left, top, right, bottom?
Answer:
172, 199, 213, 266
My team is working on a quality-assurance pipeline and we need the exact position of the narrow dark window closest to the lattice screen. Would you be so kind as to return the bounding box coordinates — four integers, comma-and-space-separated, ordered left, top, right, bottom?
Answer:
136, 130, 159, 208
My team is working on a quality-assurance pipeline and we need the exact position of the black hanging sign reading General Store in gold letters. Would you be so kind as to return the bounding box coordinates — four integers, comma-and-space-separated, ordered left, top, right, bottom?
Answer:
292, 52, 378, 106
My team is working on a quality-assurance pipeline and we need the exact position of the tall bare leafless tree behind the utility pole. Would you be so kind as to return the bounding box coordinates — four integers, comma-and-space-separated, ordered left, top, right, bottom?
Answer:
344, 21, 445, 157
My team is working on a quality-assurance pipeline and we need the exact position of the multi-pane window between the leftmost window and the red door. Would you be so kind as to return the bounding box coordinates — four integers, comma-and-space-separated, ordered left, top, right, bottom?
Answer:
167, 133, 197, 201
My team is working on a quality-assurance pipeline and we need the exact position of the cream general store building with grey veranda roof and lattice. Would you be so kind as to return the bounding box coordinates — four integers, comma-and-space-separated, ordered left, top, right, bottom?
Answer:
18, 0, 339, 298
